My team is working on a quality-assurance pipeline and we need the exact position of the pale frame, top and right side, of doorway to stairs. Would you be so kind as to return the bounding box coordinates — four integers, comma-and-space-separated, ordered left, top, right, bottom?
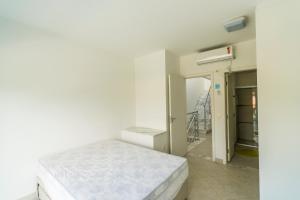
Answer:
183, 72, 216, 162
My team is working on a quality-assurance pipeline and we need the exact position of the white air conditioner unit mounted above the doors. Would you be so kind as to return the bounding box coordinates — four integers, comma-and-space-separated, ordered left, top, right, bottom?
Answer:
197, 46, 234, 65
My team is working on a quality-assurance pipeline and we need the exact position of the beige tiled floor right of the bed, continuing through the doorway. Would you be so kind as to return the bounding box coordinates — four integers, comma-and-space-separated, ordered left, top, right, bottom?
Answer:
187, 134, 259, 200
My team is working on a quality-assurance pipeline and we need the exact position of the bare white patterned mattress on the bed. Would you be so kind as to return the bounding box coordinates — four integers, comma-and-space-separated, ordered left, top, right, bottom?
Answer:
38, 140, 188, 200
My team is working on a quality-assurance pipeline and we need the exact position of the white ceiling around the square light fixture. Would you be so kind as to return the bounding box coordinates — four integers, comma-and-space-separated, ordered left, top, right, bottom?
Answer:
0, 0, 259, 57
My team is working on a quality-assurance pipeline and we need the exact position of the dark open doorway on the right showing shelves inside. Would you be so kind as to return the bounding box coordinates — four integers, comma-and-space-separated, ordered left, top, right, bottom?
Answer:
225, 70, 259, 168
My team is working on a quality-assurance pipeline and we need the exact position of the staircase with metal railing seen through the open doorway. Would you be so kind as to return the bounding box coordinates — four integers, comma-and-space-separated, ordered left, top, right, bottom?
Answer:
187, 88, 211, 143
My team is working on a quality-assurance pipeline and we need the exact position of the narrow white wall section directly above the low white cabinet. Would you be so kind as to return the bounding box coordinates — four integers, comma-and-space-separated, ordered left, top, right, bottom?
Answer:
135, 50, 167, 130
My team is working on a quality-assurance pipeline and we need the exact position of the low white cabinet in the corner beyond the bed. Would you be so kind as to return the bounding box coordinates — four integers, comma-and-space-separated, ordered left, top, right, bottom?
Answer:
121, 127, 169, 153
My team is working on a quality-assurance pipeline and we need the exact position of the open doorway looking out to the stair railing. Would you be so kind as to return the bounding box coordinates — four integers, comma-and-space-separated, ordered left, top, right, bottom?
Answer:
186, 75, 212, 160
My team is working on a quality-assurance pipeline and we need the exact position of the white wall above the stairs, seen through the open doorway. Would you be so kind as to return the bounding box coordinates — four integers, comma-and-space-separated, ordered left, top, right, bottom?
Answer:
186, 77, 210, 113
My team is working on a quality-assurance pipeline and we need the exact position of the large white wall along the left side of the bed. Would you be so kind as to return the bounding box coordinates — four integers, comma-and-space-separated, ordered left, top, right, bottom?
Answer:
0, 20, 135, 200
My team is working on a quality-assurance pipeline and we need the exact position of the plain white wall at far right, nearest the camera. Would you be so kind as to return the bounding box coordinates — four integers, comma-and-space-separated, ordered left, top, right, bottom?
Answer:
256, 0, 300, 200
